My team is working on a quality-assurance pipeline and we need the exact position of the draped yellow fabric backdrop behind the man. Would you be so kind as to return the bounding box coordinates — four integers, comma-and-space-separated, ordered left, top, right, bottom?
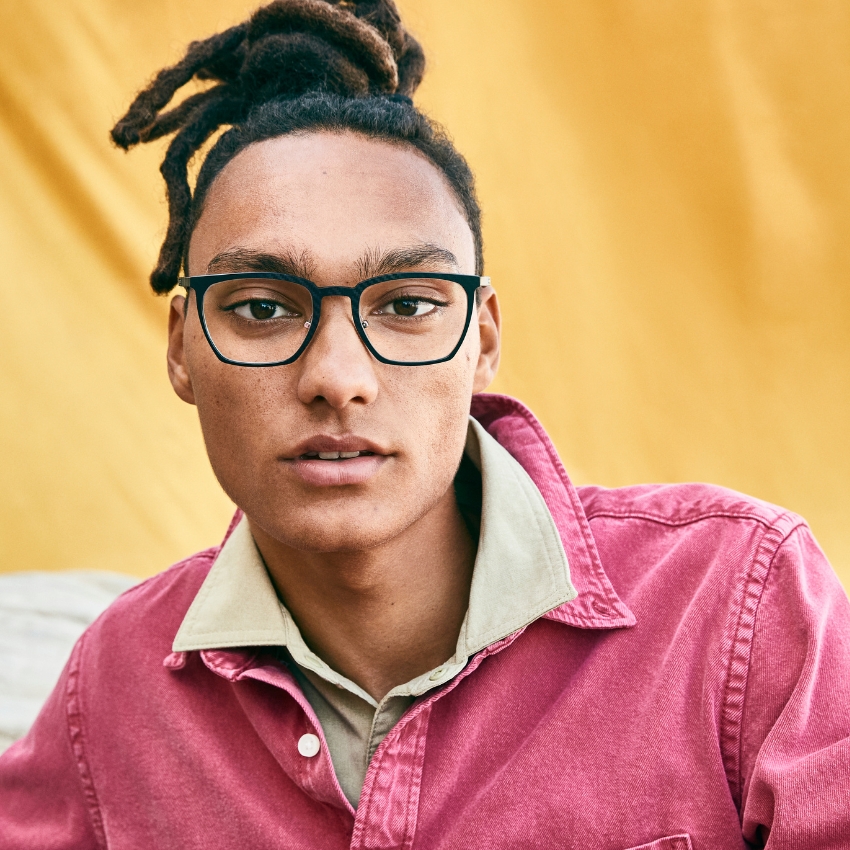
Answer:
0, 0, 850, 584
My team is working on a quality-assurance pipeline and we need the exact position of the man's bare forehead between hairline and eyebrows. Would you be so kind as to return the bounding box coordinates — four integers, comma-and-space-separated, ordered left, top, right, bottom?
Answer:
189, 132, 475, 274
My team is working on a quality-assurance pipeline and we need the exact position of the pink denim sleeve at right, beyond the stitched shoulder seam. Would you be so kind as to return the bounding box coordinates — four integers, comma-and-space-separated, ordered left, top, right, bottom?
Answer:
732, 526, 850, 850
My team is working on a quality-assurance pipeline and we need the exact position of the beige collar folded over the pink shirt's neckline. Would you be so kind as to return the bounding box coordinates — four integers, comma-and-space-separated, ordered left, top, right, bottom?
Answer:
173, 418, 577, 705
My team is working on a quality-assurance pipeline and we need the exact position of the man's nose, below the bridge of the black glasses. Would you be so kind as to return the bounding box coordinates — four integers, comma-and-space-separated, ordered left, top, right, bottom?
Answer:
296, 296, 378, 410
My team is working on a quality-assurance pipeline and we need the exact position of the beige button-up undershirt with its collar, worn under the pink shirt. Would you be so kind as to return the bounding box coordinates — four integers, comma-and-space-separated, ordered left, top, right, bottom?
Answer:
173, 419, 576, 808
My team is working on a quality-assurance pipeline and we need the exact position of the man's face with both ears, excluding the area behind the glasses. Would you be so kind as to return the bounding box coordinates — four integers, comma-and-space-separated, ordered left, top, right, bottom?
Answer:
169, 133, 499, 552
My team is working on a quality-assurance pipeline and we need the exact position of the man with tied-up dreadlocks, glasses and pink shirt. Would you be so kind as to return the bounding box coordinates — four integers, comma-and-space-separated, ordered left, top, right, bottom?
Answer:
0, 0, 850, 850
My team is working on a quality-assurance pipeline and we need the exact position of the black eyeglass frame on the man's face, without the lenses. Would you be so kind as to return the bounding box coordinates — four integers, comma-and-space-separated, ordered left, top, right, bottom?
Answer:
177, 272, 490, 368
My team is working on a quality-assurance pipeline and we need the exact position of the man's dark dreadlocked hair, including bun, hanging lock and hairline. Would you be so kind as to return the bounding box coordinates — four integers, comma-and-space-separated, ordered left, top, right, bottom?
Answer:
112, 0, 483, 293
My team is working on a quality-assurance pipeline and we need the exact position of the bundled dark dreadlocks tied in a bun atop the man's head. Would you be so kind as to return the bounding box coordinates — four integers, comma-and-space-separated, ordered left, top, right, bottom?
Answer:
112, 0, 425, 149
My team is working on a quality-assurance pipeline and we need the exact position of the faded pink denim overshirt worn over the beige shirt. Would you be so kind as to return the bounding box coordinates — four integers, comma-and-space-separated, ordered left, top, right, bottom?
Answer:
0, 395, 850, 850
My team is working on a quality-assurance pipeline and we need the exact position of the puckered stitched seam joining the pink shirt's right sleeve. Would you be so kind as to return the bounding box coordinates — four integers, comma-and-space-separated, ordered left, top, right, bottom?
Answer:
718, 513, 805, 813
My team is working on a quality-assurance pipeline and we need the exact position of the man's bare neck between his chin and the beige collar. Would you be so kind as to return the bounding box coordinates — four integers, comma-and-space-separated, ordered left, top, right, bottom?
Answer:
249, 487, 475, 701
